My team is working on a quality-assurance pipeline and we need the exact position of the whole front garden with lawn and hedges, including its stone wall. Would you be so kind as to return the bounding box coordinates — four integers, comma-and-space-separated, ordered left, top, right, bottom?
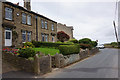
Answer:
3, 38, 99, 74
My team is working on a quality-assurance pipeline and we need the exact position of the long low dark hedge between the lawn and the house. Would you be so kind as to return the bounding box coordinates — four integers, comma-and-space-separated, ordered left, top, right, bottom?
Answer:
32, 41, 71, 48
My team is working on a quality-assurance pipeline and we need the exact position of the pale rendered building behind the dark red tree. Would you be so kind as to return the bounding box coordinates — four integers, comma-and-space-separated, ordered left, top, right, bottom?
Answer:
57, 23, 74, 39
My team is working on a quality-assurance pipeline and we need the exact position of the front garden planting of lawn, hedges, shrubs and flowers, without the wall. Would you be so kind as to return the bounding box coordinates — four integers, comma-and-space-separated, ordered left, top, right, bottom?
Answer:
3, 38, 97, 59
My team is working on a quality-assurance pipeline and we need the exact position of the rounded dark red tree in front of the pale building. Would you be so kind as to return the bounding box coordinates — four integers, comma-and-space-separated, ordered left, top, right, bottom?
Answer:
57, 31, 70, 42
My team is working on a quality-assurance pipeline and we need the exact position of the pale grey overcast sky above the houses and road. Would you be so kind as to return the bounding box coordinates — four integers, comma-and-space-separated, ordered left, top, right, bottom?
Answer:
7, 0, 116, 43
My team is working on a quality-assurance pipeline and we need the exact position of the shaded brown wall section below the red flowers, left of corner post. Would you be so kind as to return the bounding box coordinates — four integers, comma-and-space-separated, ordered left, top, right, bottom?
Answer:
2, 53, 34, 72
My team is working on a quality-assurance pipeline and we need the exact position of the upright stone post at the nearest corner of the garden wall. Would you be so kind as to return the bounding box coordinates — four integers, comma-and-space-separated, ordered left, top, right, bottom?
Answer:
34, 54, 40, 75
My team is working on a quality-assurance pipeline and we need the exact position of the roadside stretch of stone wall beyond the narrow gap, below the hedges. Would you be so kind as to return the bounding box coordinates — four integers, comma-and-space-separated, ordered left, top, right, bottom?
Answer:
52, 48, 99, 68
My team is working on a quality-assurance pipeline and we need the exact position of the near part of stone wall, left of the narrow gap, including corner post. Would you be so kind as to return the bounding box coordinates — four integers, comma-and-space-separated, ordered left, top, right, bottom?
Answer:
2, 53, 52, 75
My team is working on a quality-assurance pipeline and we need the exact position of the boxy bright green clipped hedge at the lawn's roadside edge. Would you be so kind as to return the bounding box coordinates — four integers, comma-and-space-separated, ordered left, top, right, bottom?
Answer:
59, 45, 80, 55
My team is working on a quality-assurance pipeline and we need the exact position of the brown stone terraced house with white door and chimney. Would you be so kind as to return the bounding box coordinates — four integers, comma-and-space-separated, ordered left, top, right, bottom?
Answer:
0, 0, 57, 47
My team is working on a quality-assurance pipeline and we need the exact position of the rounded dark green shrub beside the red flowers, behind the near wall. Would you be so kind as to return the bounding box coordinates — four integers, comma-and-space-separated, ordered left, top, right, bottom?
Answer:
18, 48, 35, 58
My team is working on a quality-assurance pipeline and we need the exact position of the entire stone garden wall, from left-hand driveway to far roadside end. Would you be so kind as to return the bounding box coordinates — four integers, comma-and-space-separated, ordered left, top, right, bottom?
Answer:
2, 48, 99, 75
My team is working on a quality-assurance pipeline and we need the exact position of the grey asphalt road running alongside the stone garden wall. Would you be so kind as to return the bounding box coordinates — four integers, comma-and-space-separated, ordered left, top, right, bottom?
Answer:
44, 48, 118, 78
